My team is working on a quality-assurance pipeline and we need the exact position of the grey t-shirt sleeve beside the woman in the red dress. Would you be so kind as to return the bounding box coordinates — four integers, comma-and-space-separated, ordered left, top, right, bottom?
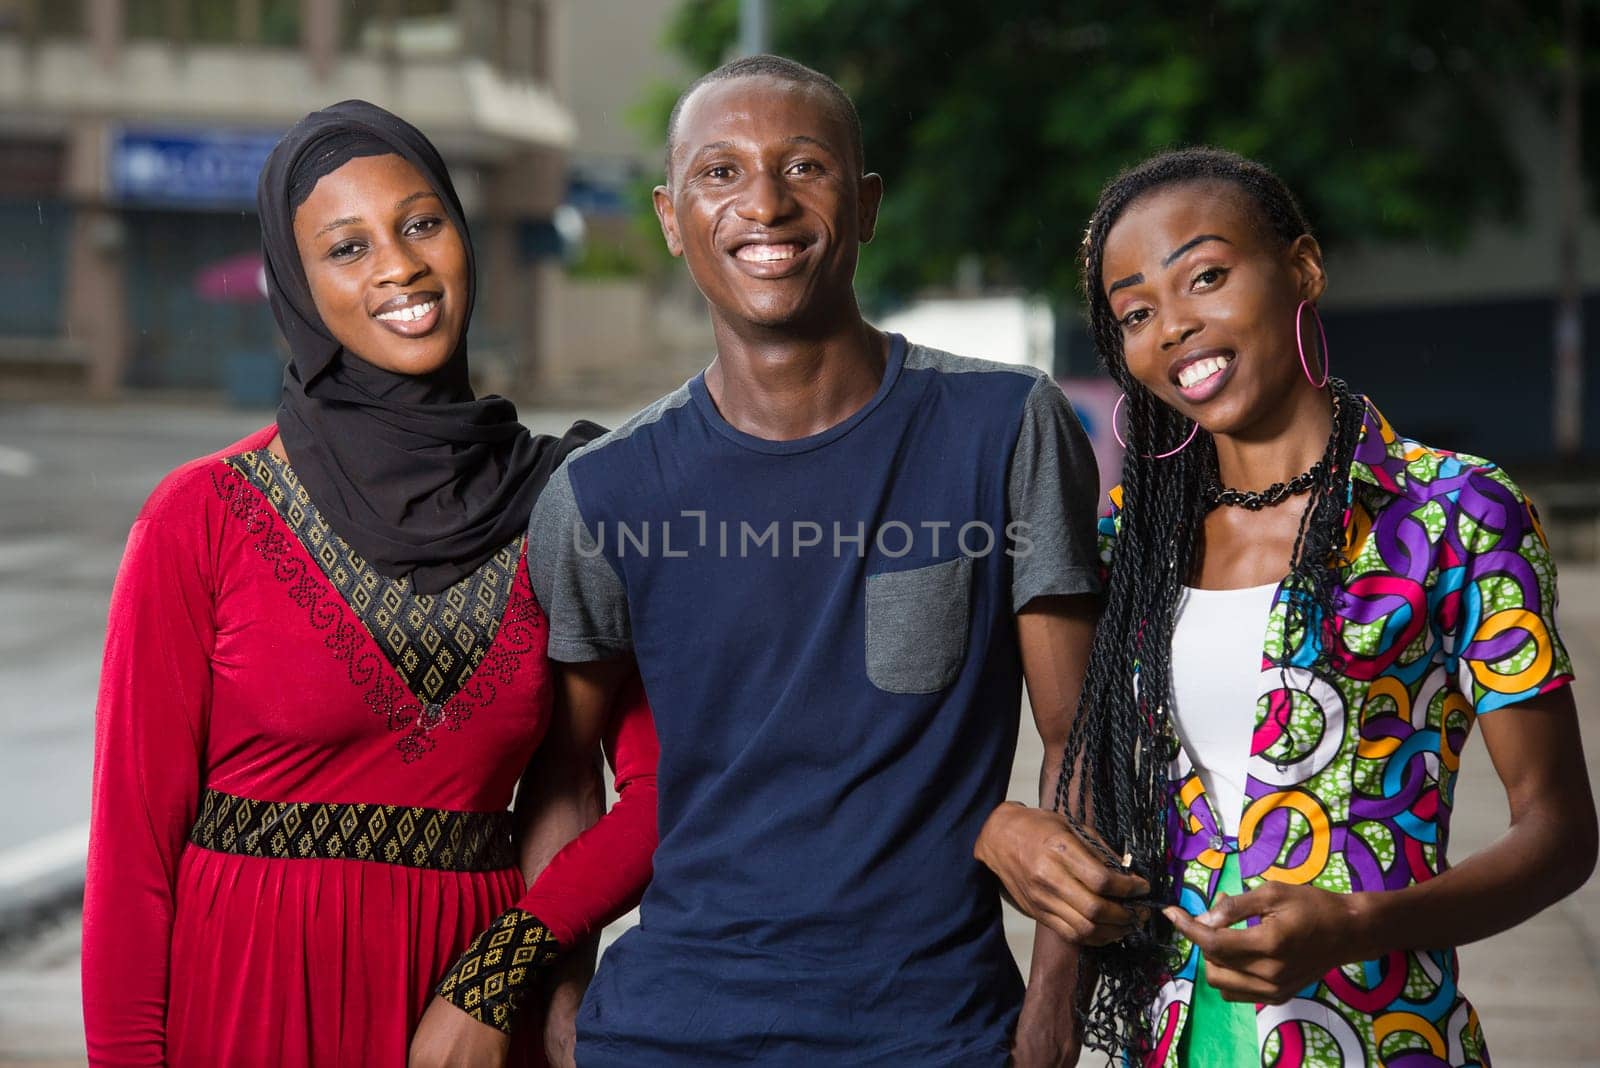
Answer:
528, 462, 634, 662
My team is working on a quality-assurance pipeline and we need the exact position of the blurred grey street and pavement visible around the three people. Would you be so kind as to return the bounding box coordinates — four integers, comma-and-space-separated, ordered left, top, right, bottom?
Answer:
0, 406, 1600, 1068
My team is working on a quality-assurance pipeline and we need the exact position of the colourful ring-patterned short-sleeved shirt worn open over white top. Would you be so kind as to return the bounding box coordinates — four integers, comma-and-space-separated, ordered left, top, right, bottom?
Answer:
1101, 398, 1571, 1068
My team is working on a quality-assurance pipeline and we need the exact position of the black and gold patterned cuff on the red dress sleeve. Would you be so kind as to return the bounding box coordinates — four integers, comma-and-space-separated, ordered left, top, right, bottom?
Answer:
438, 908, 562, 1034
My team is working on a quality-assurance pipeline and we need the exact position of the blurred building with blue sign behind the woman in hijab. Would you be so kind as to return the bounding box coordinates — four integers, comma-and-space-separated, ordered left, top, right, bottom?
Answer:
0, 0, 574, 400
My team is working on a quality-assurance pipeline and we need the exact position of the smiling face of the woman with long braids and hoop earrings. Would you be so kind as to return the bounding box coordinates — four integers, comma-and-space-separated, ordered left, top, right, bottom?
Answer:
1099, 181, 1326, 435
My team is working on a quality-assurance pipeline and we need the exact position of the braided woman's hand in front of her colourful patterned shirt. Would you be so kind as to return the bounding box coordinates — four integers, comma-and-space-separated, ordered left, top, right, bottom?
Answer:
1163, 883, 1378, 1006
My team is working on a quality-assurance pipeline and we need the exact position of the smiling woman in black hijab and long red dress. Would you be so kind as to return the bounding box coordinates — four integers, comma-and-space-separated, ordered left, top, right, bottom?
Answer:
83, 101, 656, 1065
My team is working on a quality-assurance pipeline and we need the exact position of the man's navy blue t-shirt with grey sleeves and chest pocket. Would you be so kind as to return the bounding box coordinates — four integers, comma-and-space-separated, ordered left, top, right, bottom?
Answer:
528, 337, 1098, 1068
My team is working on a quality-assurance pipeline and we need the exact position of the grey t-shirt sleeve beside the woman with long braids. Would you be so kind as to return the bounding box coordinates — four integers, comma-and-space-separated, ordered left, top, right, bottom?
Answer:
1006, 377, 1099, 612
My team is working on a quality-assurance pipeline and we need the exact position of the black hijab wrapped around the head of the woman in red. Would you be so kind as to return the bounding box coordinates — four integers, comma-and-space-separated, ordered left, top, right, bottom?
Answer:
256, 101, 603, 593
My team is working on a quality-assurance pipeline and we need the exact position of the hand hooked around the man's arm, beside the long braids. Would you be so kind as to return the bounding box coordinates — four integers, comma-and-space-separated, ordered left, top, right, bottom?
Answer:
973, 804, 1150, 945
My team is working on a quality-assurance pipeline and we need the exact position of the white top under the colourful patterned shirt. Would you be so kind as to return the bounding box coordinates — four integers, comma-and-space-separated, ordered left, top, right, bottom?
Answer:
1171, 582, 1278, 838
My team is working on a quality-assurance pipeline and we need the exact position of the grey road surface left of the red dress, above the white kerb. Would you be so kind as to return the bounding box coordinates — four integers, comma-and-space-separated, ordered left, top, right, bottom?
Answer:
0, 406, 269, 889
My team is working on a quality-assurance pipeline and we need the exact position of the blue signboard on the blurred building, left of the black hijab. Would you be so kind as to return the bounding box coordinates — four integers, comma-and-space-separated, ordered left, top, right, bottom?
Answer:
110, 130, 278, 208
